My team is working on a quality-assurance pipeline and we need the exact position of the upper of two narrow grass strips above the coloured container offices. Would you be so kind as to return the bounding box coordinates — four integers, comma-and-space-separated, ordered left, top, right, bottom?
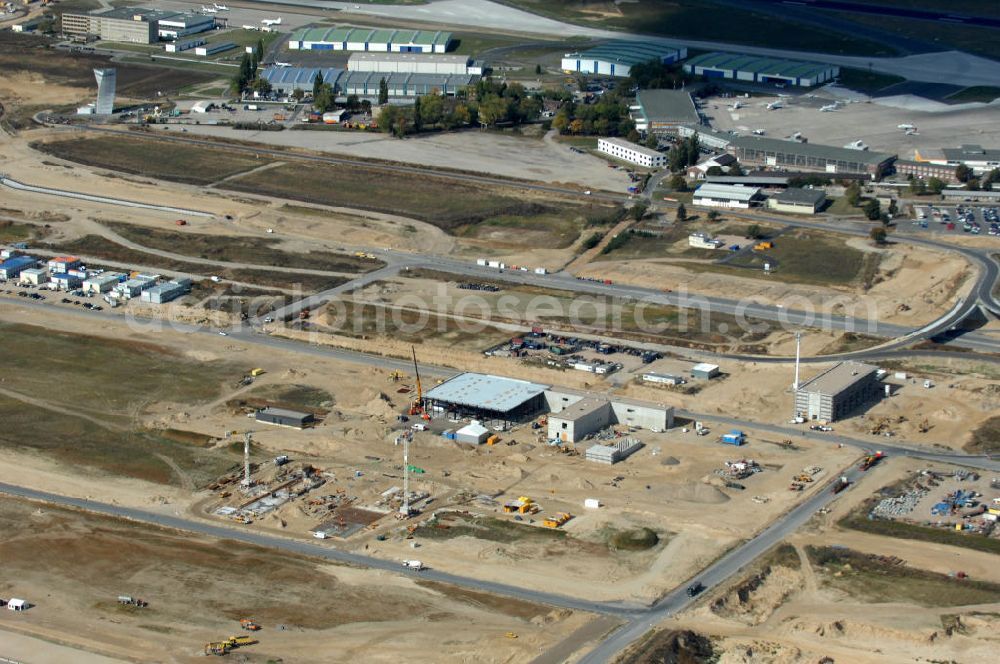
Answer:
104, 221, 385, 273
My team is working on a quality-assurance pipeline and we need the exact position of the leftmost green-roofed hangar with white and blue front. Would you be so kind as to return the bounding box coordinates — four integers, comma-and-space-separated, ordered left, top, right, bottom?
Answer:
288, 26, 454, 53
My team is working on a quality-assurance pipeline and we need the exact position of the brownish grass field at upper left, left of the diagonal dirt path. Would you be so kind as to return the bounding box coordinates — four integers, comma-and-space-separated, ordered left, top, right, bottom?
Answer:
31, 136, 270, 185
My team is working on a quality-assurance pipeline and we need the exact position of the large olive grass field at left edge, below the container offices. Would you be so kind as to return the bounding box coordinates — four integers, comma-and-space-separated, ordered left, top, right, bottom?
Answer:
0, 323, 244, 485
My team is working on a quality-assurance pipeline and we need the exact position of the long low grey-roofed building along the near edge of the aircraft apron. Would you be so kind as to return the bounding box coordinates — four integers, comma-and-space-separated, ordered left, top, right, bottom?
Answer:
728, 136, 896, 180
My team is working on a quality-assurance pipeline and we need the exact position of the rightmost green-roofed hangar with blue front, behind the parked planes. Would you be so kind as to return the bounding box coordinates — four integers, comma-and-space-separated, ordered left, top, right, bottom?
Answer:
684, 52, 840, 87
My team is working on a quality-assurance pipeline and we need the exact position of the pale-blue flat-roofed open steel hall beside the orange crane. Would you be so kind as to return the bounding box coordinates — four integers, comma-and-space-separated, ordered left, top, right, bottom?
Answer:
424, 373, 549, 422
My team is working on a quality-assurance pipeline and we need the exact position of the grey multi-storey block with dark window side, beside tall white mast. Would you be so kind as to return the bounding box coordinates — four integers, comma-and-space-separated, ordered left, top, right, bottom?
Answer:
795, 362, 881, 422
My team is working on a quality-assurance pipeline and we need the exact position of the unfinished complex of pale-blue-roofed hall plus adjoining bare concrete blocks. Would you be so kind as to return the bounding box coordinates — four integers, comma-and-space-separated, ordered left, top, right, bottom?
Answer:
424, 373, 674, 442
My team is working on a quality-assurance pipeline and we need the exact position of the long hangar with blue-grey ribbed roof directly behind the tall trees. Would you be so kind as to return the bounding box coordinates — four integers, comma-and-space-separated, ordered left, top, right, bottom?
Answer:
261, 67, 479, 99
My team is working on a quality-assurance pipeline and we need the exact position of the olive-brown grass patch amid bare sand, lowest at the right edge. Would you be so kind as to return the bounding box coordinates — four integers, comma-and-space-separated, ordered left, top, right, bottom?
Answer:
806, 546, 1000, 607
